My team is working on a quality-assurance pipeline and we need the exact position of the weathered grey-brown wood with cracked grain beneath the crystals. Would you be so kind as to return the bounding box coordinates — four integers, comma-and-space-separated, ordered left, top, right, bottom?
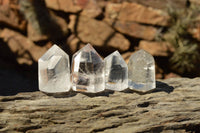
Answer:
0, 78, 200, 133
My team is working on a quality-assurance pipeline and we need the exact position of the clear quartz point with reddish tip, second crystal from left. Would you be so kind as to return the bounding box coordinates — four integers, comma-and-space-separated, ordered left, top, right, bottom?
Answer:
72, 44, 105, 93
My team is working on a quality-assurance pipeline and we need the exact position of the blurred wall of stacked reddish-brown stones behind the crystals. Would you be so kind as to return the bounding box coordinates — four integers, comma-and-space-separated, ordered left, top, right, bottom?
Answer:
0, 0, 200, 94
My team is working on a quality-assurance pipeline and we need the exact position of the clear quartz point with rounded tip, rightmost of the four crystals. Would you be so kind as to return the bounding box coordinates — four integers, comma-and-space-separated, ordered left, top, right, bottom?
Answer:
128, 50, 156, 92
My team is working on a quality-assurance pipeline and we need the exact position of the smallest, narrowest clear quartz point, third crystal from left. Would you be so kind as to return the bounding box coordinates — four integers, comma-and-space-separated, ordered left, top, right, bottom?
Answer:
104, 51, 128, 91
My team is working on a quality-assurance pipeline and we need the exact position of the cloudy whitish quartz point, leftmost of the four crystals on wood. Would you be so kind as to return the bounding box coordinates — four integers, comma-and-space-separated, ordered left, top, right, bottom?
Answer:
38, 45, 70, 93
